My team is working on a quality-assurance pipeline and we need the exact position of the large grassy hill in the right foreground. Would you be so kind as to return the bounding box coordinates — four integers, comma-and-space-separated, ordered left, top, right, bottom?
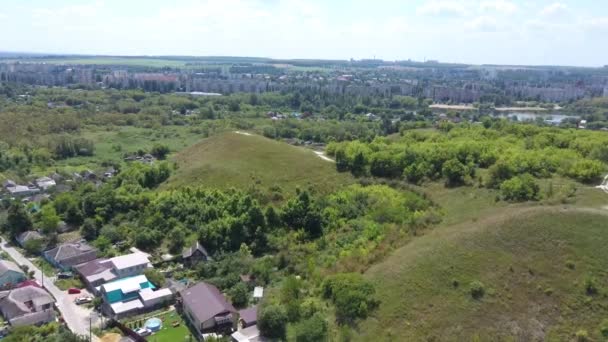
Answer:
356, 206, 608, 341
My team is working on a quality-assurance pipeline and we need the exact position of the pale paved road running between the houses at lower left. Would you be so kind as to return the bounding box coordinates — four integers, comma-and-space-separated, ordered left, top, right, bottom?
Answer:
0, 238, 99, 341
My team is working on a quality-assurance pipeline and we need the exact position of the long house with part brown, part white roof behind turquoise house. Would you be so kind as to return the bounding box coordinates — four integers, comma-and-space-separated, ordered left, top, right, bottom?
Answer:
74, 251, 152, 291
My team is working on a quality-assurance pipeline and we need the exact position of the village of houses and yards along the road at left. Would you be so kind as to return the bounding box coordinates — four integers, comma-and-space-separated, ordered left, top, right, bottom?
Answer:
0, 171, 264, 342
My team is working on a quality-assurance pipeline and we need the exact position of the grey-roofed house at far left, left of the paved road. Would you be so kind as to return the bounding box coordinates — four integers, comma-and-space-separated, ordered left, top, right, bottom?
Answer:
0, 286, 55, 326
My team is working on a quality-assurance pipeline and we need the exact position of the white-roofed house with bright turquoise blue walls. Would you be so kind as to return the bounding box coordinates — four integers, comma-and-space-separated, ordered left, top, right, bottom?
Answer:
97, 275, 173, 319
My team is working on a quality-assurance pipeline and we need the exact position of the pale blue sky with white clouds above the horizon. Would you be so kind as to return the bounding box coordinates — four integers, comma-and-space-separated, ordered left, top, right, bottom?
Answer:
0, 0, 608, 66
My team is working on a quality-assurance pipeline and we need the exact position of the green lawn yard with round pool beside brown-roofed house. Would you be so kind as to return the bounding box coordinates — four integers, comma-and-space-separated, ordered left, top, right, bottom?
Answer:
125, 310, 196, 342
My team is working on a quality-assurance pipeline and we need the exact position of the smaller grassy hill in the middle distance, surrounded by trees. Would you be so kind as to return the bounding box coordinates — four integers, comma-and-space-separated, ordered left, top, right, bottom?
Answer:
164, 132, 354, 196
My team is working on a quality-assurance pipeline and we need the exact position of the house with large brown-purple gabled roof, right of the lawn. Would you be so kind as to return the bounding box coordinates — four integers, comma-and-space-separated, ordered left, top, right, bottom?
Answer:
180, 282, 236, 335
